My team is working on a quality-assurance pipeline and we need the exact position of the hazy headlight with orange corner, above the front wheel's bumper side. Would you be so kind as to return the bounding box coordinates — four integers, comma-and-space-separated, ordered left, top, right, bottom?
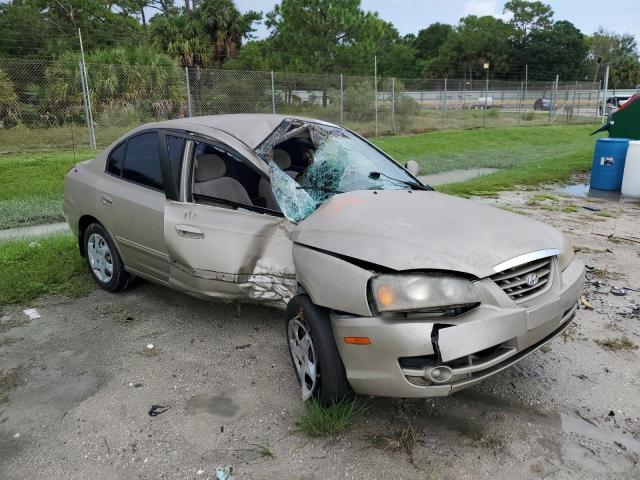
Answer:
371, 274, 480, 312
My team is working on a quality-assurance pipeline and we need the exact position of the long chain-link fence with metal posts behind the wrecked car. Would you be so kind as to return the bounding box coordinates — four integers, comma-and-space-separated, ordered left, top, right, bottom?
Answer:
0, 58, 606, 154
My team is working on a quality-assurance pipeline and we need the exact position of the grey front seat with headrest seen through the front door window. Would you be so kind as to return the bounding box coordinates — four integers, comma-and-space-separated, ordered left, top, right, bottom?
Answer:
193, 154, 253, 205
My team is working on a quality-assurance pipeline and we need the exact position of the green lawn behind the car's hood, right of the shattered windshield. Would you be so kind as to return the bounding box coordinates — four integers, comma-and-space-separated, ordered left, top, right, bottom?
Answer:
374, 125, 595, 175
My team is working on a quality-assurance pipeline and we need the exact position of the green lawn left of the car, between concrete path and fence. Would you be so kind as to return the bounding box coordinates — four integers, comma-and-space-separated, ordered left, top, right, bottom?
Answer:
0, 149, 94, 229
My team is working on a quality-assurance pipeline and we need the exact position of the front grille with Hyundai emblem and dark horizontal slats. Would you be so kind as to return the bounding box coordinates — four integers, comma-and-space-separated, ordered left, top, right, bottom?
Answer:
491, 257, 553, 303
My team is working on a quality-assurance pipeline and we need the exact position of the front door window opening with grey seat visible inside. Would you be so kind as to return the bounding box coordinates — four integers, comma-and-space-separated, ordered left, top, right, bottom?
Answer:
192, 143, 264, 206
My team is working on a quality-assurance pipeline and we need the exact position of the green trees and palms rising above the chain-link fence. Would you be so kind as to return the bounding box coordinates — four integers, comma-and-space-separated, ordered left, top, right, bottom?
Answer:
0, 0, 640, 88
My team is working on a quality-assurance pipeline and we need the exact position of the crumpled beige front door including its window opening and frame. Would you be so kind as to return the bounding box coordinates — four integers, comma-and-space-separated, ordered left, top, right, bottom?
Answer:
164, 140, 297, 304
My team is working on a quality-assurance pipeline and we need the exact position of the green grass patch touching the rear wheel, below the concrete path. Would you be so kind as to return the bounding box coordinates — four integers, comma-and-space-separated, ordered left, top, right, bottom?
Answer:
0, 235, 94, 307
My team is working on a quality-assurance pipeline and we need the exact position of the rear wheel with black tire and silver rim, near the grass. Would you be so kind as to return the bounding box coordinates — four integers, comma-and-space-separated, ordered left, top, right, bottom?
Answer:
83, 223, 133, 293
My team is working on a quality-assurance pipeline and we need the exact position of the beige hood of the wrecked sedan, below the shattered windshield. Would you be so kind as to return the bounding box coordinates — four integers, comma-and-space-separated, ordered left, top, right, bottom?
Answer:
291, 190, 564, 278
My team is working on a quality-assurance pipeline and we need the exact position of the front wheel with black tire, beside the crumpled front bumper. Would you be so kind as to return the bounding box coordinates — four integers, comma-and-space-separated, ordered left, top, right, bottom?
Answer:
285, 294, 355, 407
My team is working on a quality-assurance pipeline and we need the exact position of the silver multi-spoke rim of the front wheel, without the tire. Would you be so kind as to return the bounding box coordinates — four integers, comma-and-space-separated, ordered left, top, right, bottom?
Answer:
288, 316, 318, 401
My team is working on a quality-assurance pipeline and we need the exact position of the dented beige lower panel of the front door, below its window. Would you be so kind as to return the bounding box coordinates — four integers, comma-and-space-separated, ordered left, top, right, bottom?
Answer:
164, 201, 297, 303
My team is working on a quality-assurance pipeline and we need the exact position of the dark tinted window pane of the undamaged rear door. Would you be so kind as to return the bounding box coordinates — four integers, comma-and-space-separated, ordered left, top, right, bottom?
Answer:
122, 132, 164, 190
